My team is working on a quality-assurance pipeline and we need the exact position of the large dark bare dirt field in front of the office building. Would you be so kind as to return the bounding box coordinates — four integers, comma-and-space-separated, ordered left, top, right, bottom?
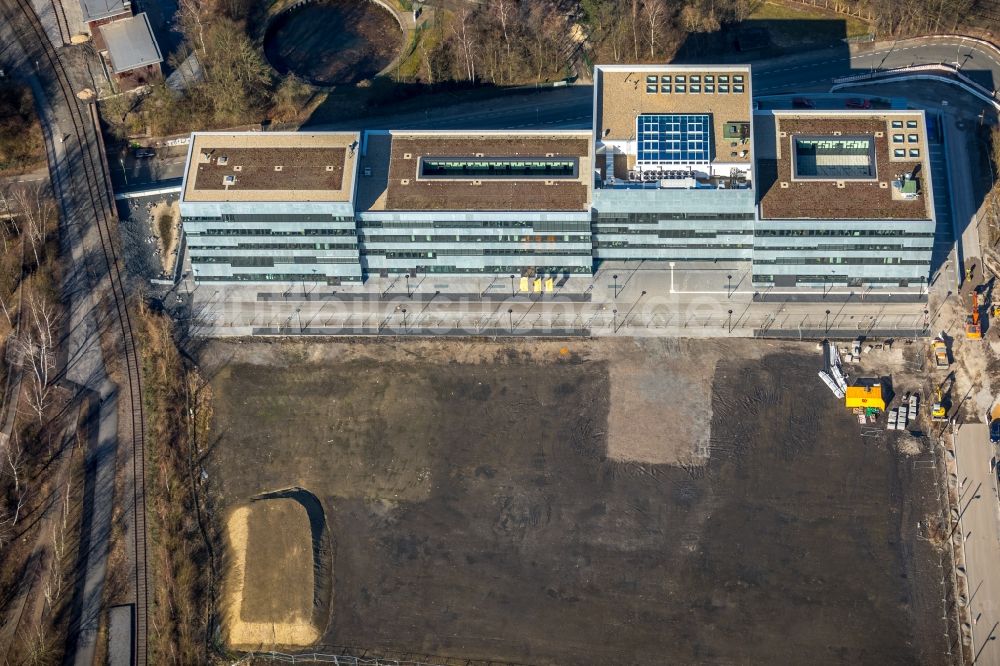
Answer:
200, 339, 951, 664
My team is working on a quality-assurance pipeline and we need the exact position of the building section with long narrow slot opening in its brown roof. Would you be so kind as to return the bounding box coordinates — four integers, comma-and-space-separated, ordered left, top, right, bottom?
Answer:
357, 131, 593, 276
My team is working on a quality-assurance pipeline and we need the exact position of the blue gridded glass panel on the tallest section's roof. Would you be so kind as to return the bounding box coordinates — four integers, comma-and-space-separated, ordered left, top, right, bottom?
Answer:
636, 113, 712, 164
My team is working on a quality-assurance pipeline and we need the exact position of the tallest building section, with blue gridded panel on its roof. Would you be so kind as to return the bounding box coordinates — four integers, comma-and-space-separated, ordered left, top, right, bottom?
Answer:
593, 65, 755, 262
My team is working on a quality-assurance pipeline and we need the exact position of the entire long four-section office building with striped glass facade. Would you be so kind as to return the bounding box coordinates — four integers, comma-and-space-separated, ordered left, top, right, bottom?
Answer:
180, 65, 935, 287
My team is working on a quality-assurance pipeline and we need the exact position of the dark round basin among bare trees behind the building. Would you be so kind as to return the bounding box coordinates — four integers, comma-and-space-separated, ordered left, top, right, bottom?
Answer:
264, 0, 403, 86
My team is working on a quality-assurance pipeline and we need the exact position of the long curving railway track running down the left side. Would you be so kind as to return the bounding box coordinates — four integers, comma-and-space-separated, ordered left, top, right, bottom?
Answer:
0, 0, 149, 664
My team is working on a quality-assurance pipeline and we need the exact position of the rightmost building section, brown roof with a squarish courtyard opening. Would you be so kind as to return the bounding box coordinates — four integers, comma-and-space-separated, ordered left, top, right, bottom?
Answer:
753, 110, 935, 287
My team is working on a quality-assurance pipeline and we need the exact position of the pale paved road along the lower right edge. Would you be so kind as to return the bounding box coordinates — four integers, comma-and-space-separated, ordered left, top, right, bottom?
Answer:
955, 423, 1000, 666
